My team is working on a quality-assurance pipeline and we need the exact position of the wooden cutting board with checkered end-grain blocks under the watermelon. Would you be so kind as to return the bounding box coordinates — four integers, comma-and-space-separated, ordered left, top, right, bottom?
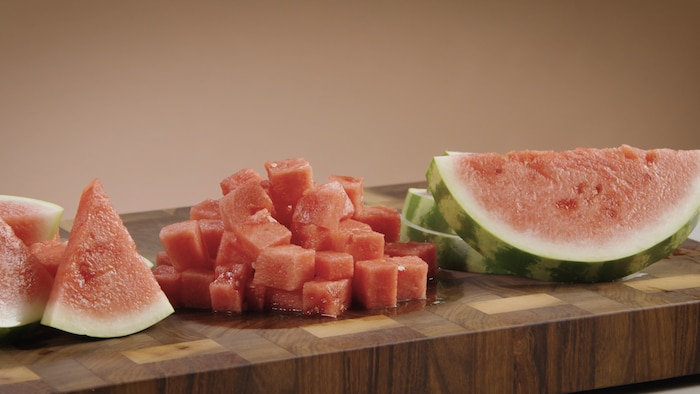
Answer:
0, 184, 700, 393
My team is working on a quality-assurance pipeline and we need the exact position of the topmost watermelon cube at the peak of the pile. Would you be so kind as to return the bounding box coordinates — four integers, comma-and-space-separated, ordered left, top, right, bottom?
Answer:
265, 157, 315, 225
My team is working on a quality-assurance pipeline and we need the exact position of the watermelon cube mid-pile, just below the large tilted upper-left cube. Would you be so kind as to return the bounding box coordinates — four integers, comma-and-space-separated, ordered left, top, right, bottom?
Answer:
234, 215, 292, 260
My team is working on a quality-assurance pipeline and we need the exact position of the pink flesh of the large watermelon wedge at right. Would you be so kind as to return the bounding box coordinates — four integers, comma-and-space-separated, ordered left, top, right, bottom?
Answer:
446, 146, 700, 260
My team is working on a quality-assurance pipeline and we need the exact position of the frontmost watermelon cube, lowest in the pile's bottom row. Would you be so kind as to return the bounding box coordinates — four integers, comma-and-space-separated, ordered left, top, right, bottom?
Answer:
302, 279, 352, 317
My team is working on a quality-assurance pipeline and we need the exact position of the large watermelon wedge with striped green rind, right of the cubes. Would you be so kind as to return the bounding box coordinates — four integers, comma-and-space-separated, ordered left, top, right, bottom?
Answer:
426, 145, 700, 282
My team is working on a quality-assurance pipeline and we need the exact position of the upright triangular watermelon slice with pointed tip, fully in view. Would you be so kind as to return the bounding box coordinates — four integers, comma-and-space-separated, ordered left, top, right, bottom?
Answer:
41, 179, 174, 338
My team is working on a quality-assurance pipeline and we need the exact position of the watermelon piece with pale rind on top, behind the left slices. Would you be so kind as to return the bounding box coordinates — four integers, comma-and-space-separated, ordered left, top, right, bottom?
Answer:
0, 195, 63, 245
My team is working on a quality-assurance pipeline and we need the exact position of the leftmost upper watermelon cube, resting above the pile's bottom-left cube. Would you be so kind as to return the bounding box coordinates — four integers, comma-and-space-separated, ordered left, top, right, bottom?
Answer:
160, 219, 214, 271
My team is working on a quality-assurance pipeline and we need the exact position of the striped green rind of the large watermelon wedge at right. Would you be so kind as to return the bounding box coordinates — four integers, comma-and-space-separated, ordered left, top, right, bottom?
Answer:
426, 157, 700, 283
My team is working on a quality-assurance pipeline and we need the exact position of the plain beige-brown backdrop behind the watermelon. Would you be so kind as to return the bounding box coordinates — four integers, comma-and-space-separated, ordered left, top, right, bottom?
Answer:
0, 0, 700, 218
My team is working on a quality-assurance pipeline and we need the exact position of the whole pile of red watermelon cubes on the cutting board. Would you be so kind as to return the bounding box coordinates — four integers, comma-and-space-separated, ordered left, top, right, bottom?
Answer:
153, 158, 437, 317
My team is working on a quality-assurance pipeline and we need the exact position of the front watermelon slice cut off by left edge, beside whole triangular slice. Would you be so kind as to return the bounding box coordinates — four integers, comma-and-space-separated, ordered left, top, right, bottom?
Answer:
0, 219, 53, 341
